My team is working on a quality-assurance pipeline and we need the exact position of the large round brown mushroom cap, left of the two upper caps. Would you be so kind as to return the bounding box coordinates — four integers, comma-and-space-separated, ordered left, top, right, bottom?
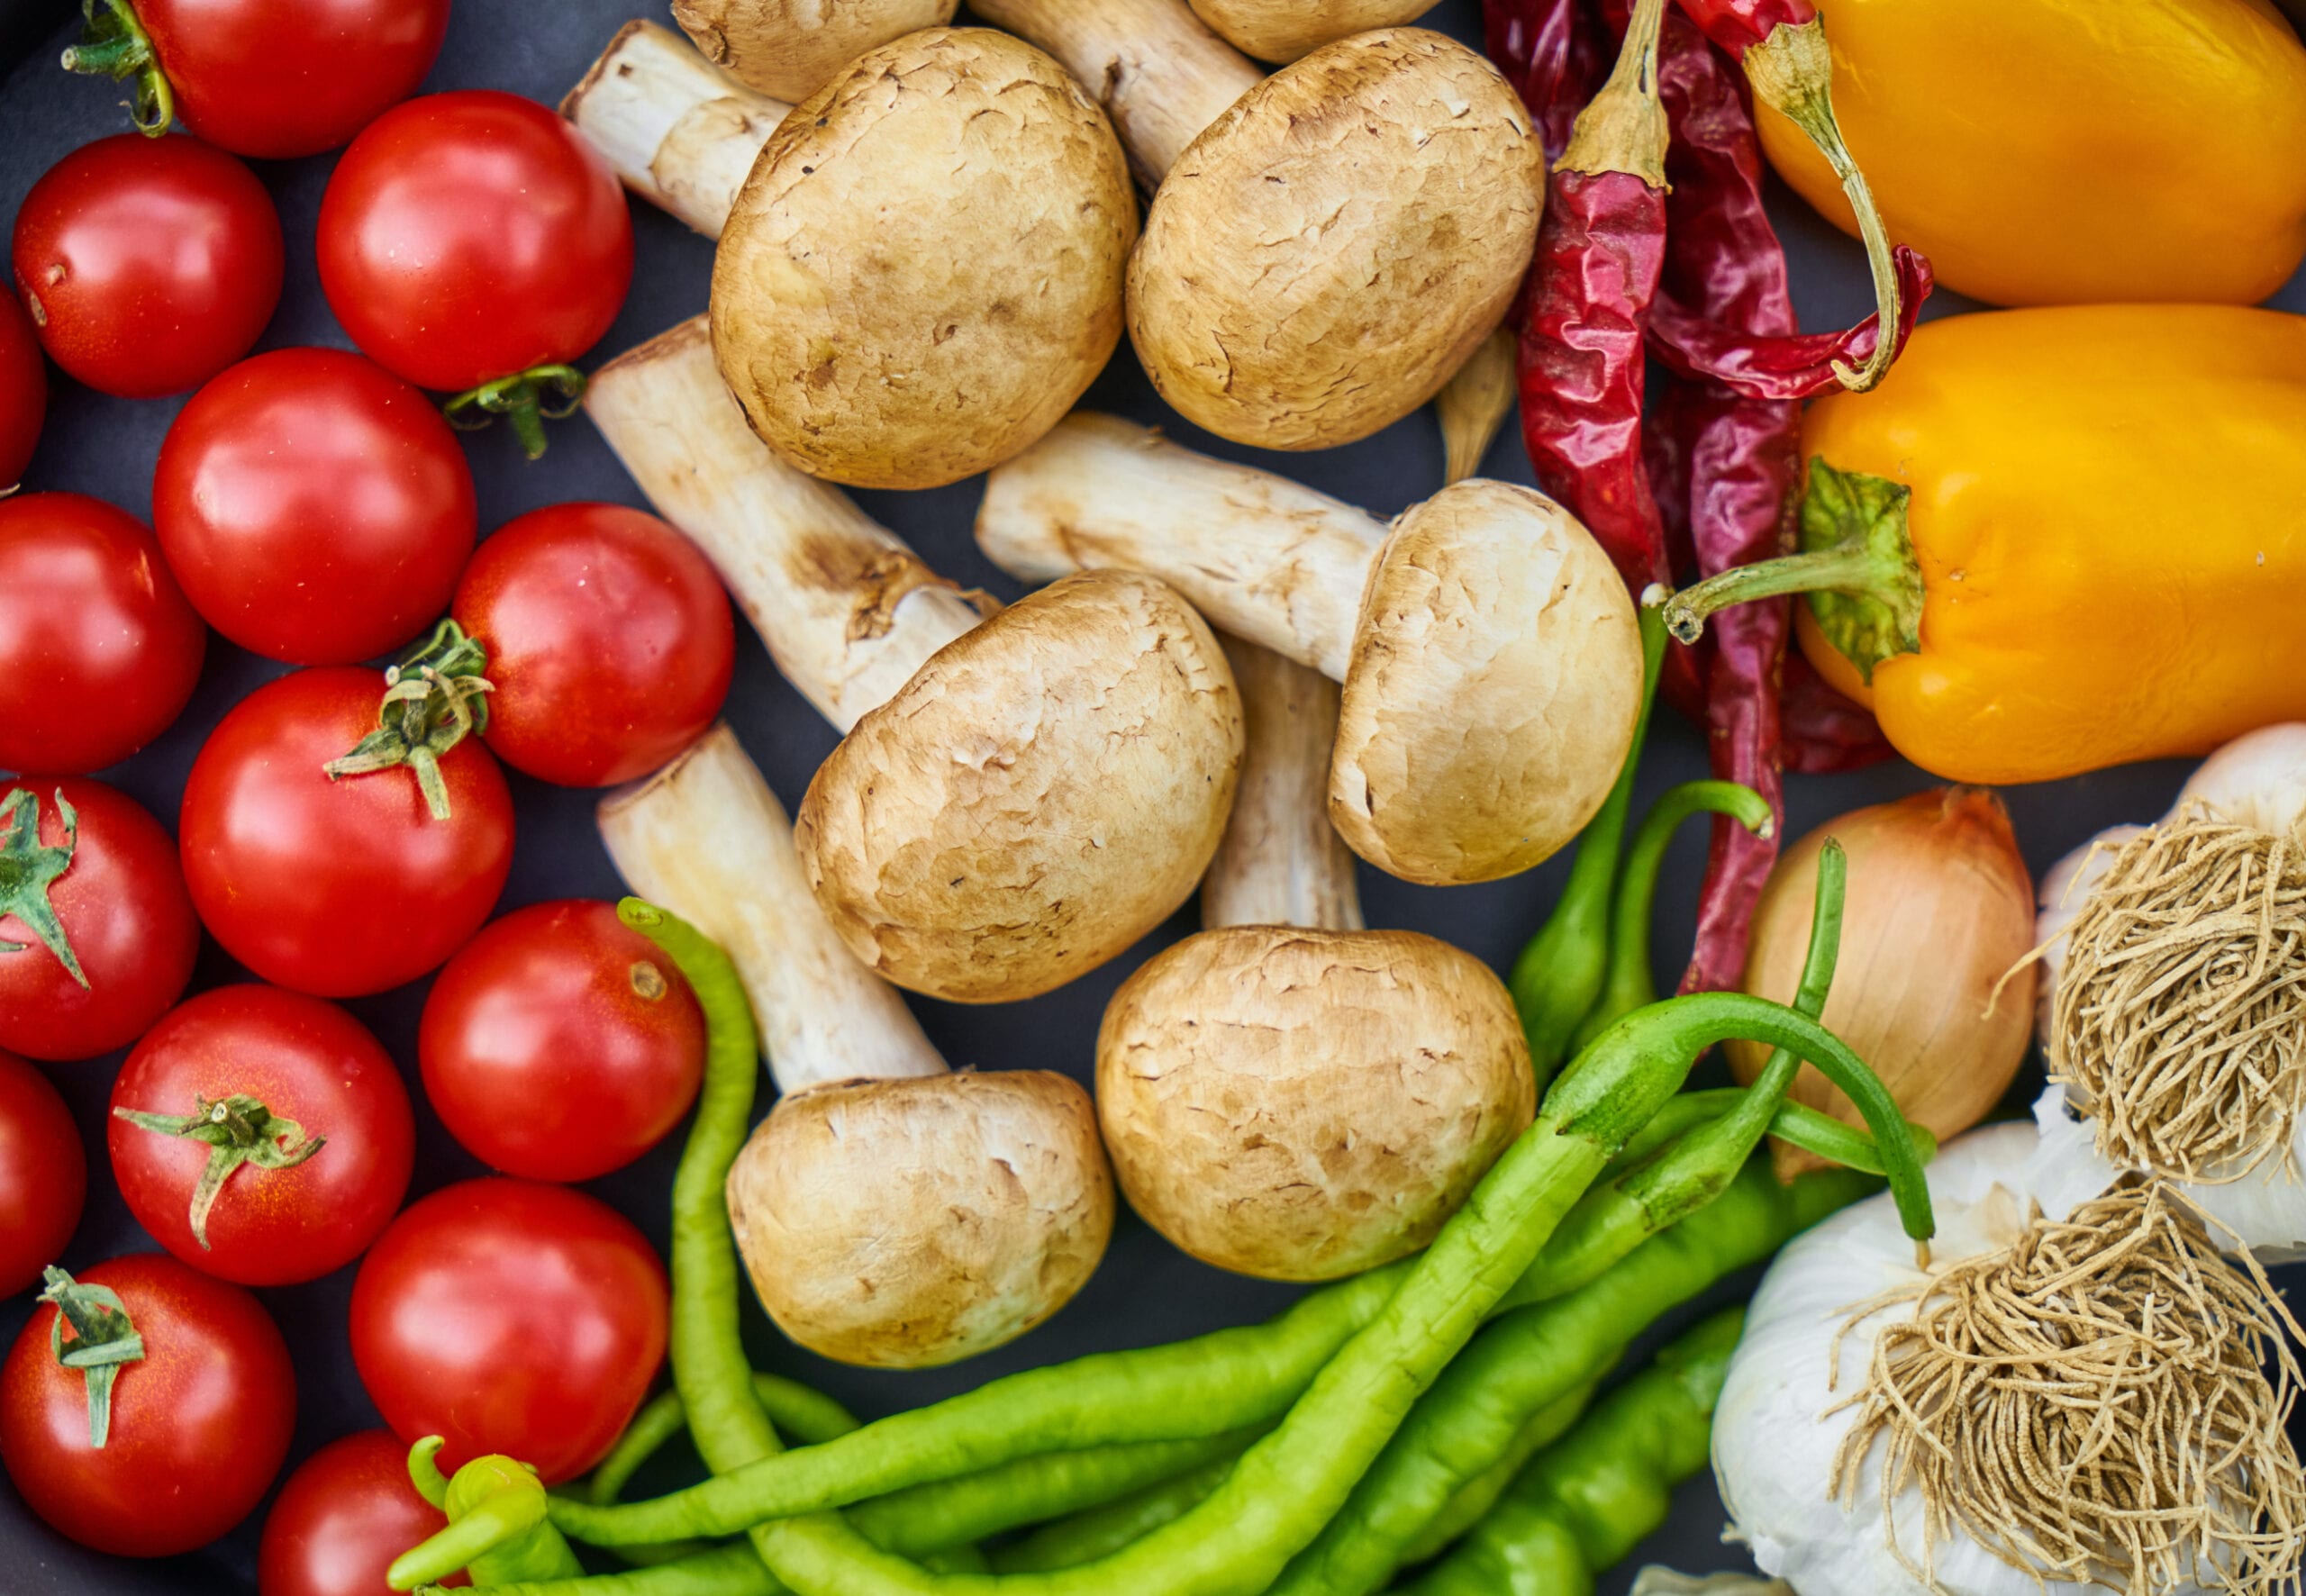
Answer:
713, 28, 1137, 486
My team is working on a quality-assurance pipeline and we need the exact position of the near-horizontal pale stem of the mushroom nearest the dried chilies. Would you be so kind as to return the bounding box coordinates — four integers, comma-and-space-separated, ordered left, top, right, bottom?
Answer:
977, 411, 1386, 680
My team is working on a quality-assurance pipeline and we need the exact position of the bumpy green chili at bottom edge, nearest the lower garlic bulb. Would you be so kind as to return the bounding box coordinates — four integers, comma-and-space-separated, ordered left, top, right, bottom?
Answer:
1402, 1310, 1743, 1596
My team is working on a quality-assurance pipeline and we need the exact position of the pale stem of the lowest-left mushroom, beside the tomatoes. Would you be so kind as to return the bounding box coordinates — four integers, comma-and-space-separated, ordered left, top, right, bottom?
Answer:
600, 727, 946, 1095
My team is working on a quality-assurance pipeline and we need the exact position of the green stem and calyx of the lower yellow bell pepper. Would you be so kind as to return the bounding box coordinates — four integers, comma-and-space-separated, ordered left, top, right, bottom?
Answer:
1665, 451, 1923, 683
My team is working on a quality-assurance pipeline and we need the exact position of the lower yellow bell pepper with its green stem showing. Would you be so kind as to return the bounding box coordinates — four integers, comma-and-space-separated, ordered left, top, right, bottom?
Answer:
1665, 304, 2306, 782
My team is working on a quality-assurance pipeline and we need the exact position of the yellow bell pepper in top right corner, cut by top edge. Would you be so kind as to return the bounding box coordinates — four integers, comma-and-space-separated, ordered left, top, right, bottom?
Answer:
1759, 0, 2306, 304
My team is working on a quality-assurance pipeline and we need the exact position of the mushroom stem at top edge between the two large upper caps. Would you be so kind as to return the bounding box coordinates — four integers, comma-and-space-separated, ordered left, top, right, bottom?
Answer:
971, 0, 1266, 186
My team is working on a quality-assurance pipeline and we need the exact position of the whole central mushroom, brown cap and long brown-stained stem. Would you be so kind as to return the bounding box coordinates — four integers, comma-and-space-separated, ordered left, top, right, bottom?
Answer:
586, 321, 1240, 1003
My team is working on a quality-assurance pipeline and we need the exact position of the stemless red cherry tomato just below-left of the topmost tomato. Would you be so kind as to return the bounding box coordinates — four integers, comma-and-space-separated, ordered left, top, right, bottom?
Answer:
14, 134, 281, 399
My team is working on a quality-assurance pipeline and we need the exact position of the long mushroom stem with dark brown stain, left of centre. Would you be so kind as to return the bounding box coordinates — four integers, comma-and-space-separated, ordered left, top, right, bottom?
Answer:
586, 316, 989, 731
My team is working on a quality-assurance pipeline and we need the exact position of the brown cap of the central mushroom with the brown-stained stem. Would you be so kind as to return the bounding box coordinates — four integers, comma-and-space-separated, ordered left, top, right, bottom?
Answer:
795, 572, 1240, 1003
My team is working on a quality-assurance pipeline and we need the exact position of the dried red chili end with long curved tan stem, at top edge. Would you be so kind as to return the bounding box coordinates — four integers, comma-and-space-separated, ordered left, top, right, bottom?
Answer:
1681, 0, 1911, 392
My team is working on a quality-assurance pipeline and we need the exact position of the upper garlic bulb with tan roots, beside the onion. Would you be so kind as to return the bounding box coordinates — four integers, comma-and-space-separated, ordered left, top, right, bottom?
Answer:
2031, 721, 2306, 1262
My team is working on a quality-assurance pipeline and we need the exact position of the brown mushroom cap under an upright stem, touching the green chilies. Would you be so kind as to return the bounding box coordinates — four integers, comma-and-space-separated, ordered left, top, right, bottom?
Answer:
1098, 925, 1536, 1280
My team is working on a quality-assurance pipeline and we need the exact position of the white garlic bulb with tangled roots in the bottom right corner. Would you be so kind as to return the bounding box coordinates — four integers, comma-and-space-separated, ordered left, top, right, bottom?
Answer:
1713, 1123, 2306, 1596
